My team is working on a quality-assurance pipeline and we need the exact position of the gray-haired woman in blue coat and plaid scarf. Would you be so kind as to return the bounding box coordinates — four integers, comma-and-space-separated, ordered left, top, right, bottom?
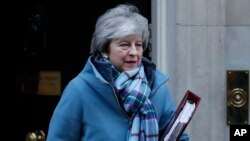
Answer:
47, 4, 189, 141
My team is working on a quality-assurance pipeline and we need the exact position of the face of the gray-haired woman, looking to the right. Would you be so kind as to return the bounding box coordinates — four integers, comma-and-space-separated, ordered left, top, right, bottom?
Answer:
107, 35, 143, 71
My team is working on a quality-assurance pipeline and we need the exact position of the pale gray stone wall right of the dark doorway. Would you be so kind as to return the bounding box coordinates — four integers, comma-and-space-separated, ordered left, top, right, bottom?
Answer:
152, 0, 250, 141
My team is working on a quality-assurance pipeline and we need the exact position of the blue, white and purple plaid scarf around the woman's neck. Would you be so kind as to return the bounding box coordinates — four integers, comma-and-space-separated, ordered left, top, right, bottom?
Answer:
115, 65, 159, 141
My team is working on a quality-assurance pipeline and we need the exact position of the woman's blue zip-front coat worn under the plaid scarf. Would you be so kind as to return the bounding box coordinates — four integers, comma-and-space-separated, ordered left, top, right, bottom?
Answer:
47, 58, 188, 141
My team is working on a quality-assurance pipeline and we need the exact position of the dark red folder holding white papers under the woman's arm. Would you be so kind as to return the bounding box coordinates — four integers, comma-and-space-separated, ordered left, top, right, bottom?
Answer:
160, 90, 201, 141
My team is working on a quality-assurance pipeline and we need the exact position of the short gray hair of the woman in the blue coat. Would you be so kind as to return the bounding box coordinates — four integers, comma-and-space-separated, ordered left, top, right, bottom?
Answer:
90, 4, 149, 55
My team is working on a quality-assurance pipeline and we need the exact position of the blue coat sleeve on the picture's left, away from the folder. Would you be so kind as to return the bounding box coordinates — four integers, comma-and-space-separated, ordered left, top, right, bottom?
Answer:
46, 79, 83, 141
